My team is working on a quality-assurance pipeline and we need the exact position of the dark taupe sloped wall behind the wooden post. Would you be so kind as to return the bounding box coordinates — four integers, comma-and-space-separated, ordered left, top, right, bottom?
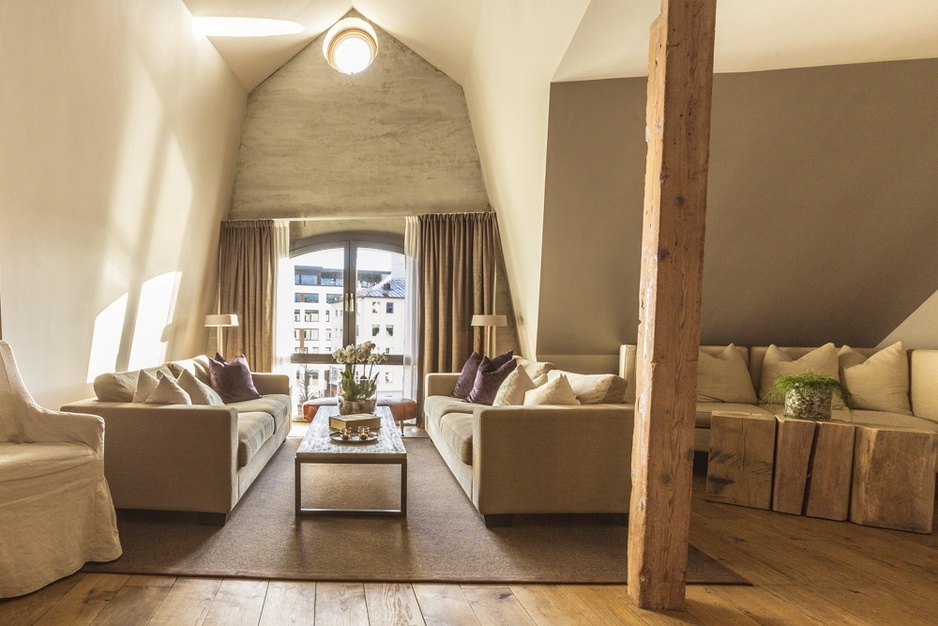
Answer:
538, 59, 938, 363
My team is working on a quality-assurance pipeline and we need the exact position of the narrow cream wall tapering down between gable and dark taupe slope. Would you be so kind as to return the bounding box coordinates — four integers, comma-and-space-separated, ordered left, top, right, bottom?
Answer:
464, 0, 589, 356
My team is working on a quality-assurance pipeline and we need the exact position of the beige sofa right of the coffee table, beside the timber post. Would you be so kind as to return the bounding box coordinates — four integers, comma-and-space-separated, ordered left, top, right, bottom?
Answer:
424, 374, 633, 526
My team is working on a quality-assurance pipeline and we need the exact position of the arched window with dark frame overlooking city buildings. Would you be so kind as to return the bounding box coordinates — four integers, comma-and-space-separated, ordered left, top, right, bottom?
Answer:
281, 233, 409, 410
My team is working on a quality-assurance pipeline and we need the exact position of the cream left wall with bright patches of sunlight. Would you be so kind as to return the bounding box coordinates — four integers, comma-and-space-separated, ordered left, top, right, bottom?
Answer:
0, 0, 246, 407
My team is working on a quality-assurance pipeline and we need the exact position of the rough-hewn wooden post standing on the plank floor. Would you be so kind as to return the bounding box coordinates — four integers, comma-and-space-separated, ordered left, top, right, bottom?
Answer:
628, 0, 716, 609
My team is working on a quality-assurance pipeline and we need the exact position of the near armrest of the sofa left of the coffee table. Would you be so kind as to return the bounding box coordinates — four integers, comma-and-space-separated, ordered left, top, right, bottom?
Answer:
62, 400, 238, 513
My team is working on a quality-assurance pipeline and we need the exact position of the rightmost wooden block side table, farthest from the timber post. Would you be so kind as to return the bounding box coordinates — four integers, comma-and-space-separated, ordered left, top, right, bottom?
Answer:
850, 425, 938, 533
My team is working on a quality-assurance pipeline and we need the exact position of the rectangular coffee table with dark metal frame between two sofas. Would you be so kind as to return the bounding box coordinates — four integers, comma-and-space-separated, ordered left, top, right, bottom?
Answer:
294, 406, 407, 517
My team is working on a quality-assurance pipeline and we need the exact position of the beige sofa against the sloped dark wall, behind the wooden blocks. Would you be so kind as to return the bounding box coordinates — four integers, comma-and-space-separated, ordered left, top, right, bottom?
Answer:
619, 345, 938, 452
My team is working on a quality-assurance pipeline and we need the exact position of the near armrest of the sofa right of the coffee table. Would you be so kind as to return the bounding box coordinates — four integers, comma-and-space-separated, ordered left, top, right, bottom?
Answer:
472, 404, 634, 515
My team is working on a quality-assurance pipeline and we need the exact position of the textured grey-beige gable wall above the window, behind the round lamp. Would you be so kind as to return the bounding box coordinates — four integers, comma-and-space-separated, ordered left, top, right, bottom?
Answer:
231, 12, 488, 219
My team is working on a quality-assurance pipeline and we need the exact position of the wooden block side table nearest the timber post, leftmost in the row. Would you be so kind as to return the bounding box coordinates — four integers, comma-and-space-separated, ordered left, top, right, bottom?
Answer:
707, 411, 775, 509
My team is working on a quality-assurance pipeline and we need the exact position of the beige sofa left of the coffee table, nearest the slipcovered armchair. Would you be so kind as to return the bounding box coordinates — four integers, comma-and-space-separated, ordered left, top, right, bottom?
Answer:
62, 356, 292, 525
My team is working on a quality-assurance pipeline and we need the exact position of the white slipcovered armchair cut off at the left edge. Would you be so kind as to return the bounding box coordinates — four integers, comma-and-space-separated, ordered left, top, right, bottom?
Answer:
0, 341, 121, 598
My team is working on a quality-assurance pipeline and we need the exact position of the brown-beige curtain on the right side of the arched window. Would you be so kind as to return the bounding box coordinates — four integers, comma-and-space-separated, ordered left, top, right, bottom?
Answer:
418, 213, 501, 382
